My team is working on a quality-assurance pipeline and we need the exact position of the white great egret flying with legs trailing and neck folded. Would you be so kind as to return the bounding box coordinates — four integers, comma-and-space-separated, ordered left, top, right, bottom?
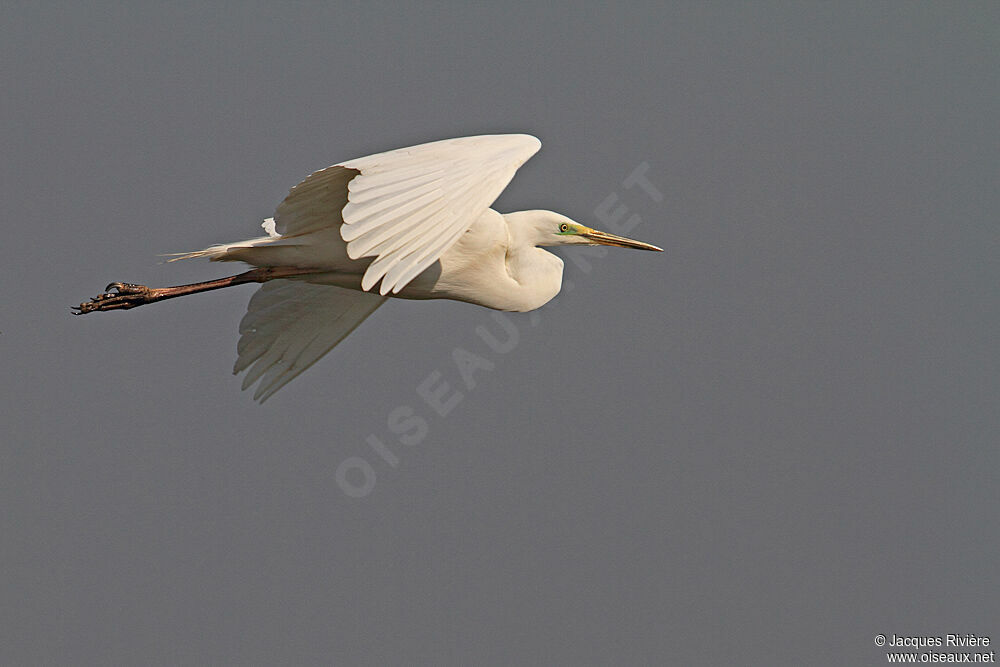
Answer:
76, 134, 660, 402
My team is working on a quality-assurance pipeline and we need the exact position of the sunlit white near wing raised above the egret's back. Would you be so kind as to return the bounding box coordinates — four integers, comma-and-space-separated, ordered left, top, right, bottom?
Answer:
275, 134, 541, 295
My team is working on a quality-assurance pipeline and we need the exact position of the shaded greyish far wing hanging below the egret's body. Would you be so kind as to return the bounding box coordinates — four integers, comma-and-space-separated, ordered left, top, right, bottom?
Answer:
233, 280, 386, 403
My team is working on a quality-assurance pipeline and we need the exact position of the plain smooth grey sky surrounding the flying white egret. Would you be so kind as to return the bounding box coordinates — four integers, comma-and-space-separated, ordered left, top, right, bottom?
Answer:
0, 2, 1000, 665
